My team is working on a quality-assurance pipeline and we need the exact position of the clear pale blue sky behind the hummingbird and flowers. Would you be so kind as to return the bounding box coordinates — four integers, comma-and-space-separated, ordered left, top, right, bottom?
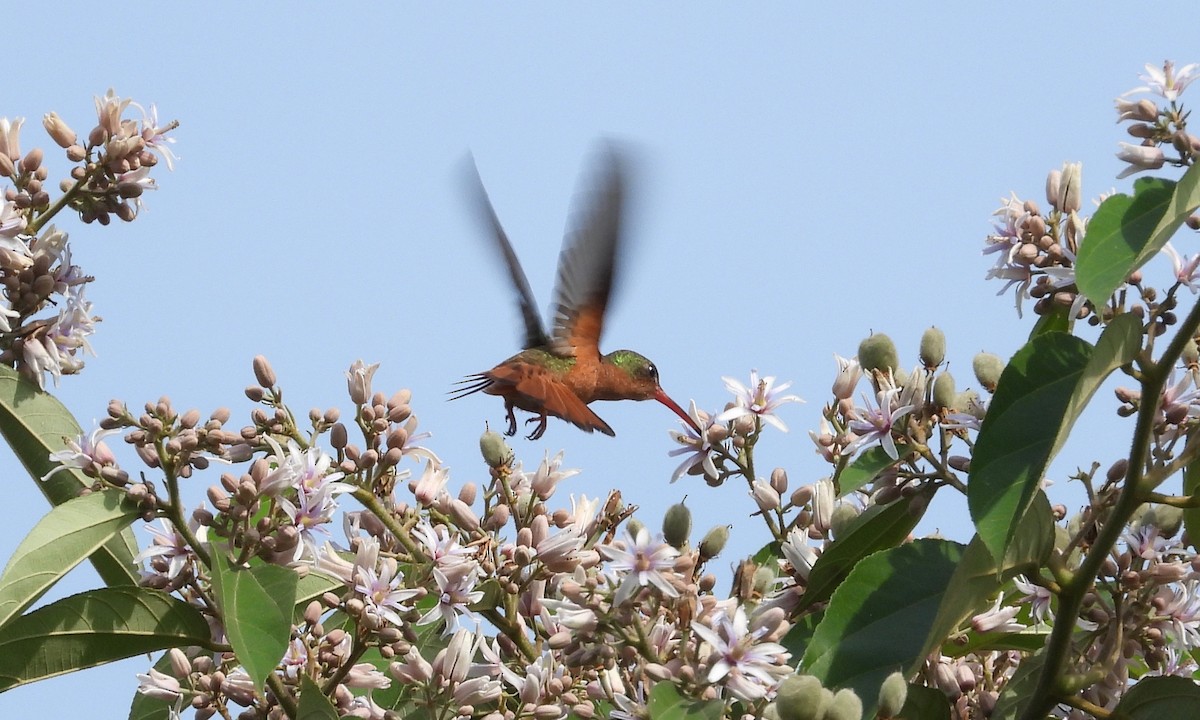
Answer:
0, 2, 1200, 718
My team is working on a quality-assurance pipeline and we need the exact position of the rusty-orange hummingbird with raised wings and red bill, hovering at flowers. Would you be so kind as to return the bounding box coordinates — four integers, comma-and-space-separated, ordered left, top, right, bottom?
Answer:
450, 146, 700, 440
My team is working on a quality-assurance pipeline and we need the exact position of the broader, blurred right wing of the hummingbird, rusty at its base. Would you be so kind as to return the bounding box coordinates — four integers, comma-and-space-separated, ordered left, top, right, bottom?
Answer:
551, 146, 626, 359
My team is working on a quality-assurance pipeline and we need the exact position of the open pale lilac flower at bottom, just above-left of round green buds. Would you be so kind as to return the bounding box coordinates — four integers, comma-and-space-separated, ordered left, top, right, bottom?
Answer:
691, 605, 792, 702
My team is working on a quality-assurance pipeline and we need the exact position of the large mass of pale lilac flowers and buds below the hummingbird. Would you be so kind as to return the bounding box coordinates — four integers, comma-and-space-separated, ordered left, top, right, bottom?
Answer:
55, 358, 816, 719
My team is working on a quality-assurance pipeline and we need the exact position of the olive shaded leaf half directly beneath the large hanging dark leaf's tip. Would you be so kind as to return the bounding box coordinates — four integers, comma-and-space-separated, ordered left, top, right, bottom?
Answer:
924, 491, 1055, 655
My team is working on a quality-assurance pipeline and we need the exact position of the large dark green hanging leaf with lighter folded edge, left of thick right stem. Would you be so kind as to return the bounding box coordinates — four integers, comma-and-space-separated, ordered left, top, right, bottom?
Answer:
967, 314, 1141, 558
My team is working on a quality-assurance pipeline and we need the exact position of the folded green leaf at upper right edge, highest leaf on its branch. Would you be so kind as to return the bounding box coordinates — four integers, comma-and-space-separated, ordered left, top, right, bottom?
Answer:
1075, 166, 1200, 305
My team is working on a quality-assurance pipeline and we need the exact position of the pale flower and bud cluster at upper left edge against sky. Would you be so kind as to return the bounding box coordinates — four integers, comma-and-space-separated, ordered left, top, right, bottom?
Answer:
0, 90, 178, 384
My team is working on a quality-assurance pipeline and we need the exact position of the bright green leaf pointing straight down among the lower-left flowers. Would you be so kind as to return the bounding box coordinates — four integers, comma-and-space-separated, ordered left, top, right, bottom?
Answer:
212, 557, 299, 690
